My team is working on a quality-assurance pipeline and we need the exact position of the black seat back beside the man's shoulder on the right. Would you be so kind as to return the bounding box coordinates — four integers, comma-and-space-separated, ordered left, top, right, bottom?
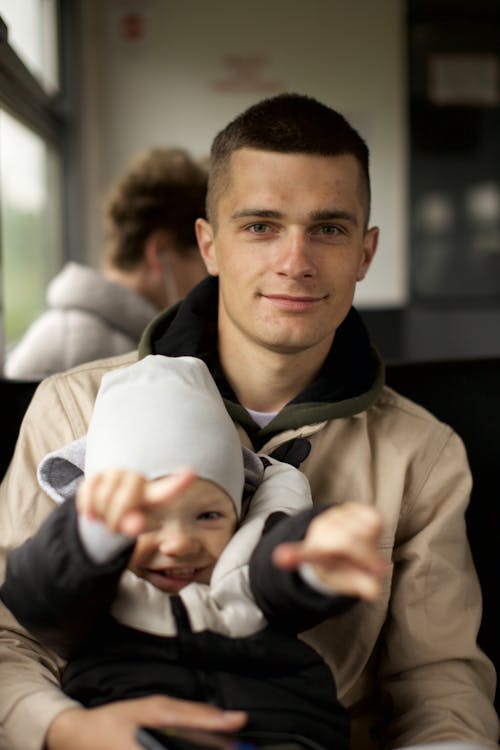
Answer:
387, 359, 500, 712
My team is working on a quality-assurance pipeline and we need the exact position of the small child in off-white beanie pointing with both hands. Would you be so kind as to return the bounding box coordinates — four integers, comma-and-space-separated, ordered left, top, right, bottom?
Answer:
0, 355, 385, 750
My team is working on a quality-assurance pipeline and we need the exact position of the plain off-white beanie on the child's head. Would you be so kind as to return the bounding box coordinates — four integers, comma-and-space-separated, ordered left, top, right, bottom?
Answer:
85, 355, 244, 516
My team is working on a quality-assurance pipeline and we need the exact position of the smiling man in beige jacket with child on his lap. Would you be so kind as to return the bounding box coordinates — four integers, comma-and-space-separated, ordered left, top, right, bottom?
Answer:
0, 95, 498, 750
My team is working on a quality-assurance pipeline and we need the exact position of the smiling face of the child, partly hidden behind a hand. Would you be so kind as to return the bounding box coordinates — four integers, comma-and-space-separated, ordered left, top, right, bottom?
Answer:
128, 479, 236, 594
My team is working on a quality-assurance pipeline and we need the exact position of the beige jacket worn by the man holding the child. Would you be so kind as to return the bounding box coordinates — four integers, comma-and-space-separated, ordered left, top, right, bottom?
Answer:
0, 355, 498, 750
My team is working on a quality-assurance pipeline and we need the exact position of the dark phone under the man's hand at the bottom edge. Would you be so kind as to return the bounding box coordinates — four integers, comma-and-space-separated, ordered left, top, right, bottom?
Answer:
137, 728, 316, 750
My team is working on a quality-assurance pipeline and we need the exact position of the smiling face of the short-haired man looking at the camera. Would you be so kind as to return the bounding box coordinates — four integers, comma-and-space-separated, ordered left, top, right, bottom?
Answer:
197, 148, 378, 359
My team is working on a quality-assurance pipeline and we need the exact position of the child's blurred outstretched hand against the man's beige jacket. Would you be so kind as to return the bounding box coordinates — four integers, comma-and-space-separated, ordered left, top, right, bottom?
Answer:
273, 502, 388, 601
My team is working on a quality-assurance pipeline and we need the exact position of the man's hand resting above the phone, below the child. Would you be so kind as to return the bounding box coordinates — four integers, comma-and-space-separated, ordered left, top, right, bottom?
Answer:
45, 695, 247, 750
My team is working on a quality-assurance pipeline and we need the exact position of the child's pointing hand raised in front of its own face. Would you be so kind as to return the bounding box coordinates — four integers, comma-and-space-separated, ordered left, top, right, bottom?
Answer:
76, 469, 195, 536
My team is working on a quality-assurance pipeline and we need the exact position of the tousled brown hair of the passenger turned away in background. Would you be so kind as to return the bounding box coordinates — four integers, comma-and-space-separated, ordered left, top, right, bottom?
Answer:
104, 148, 207, 270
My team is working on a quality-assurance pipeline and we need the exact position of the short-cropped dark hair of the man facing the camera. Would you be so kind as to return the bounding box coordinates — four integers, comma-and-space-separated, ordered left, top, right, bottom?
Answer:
207, 94, 370, 226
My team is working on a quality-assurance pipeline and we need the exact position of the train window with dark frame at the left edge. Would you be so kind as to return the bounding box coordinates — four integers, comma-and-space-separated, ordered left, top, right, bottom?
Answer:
0, 0, 72, 374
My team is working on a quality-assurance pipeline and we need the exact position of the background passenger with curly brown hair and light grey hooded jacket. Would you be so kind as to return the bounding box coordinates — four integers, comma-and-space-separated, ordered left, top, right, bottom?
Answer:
5, 148, 207, 380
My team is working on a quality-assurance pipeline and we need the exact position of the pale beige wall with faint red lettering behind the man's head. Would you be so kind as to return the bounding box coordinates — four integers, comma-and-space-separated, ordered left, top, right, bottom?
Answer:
82, 0, 407, 306
